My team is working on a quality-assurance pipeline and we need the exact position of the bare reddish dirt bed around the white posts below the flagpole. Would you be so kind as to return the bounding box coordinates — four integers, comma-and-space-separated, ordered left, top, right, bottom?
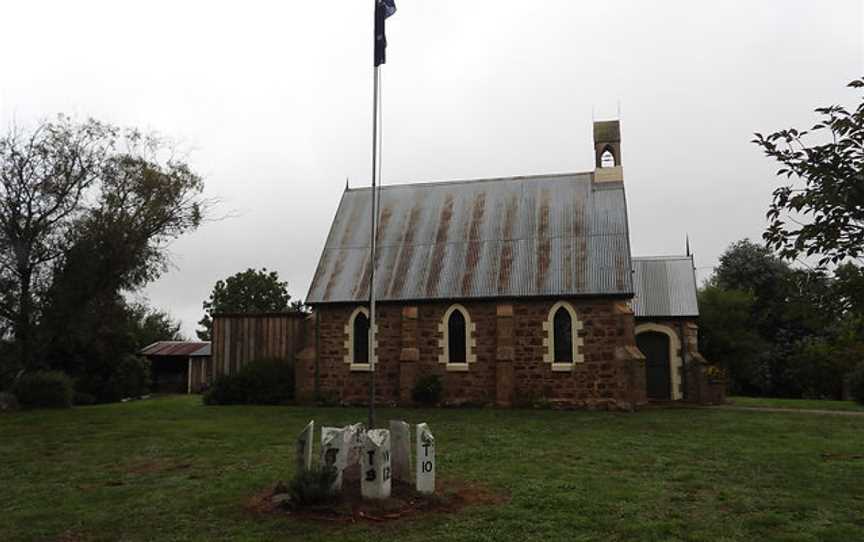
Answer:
245, 479, 510, 523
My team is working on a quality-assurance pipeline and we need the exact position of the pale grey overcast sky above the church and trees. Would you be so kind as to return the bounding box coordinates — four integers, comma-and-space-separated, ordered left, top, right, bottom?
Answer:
0, 0, 864, 336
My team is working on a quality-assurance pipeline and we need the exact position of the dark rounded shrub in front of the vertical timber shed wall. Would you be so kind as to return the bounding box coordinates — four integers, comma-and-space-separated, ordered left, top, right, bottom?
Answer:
204, 359, 294, 405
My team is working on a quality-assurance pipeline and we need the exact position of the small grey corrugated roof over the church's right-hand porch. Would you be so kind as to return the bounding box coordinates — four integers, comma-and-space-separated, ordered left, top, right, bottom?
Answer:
633, 256, 699, 317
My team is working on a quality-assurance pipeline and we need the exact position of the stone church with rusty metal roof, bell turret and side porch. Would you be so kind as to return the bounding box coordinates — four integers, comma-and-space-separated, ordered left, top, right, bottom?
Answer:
298, 121, 723, 410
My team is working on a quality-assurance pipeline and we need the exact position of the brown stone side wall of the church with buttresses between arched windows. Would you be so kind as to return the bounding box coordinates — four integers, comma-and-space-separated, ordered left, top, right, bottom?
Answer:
308, 299, 645, 409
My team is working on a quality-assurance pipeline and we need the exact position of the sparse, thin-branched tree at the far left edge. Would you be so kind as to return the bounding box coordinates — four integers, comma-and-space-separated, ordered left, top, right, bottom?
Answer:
0, 118, 118, 372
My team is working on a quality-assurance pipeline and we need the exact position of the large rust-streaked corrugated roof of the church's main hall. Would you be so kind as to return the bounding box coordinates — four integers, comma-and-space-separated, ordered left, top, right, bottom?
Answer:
306, 173, 633, 304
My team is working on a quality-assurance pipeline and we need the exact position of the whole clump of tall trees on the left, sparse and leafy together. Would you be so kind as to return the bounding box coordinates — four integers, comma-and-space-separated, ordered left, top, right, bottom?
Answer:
0, 116, 208, 378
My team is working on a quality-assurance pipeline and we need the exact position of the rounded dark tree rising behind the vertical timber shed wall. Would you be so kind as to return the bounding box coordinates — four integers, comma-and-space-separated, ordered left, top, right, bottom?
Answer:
196, 268, 304, 341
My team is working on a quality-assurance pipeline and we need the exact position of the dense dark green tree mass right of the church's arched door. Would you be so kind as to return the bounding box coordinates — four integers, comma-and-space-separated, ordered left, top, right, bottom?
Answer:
699, 239, 864, 397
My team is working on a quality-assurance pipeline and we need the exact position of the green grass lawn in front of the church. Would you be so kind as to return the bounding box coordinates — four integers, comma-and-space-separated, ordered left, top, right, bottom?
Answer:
0, 397, 864, 542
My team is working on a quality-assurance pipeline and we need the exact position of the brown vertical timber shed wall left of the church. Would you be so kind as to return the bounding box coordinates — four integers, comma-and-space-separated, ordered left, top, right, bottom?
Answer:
213, 313, 311, 377
